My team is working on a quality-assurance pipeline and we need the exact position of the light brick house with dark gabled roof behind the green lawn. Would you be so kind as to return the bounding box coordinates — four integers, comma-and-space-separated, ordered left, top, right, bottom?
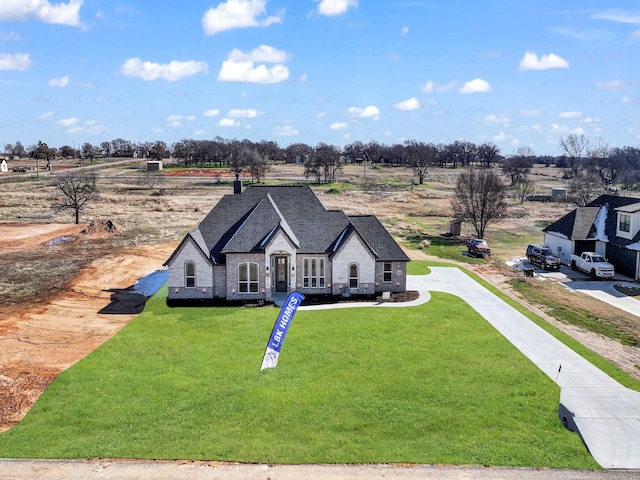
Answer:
165, 181, 409, 301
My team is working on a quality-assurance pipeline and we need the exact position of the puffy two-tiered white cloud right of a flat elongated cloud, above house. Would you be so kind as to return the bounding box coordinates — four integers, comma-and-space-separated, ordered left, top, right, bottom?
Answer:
218, 45, 289, 83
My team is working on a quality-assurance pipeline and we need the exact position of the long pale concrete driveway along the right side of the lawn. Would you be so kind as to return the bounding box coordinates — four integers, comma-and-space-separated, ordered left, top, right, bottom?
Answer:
420, 267, 640, 469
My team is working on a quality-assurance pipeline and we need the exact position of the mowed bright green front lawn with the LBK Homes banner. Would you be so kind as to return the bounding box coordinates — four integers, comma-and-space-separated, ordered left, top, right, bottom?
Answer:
0, 280, 598, 468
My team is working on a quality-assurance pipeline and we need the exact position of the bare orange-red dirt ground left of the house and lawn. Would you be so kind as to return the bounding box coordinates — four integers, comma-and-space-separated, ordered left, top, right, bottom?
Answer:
0, 224, 175, 431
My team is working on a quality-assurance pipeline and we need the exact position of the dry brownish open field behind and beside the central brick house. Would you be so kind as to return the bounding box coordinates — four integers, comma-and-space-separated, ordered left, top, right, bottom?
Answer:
0, 160, 640, 356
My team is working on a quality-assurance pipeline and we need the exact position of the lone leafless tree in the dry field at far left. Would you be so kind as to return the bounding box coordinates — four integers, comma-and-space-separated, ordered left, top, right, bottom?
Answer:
51, 173, 99, 225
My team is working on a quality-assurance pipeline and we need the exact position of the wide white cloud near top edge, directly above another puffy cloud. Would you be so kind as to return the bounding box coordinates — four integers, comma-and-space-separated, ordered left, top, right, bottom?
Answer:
202, 0, 283, 35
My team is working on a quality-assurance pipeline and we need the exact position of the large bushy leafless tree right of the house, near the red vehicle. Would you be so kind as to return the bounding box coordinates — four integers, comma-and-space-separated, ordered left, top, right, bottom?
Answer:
452, 169, 507, 238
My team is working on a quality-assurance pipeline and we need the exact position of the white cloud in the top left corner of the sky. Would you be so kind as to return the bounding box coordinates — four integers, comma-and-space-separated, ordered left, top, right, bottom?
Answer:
0, 0, 84, 27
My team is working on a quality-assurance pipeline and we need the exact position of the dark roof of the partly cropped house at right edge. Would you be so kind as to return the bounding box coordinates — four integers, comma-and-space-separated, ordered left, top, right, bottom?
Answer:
542, 195, 640, 246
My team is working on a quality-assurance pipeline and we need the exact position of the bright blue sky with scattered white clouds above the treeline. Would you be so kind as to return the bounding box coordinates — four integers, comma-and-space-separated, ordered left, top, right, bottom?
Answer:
0, 0, 640, 155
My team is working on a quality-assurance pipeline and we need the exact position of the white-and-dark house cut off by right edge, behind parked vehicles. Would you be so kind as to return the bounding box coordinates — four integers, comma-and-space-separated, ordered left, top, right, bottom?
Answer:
543, 195, 640, 280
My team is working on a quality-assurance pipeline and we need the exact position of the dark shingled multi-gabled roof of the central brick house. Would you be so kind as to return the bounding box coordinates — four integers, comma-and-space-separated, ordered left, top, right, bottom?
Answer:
170, 185, 409, 263
